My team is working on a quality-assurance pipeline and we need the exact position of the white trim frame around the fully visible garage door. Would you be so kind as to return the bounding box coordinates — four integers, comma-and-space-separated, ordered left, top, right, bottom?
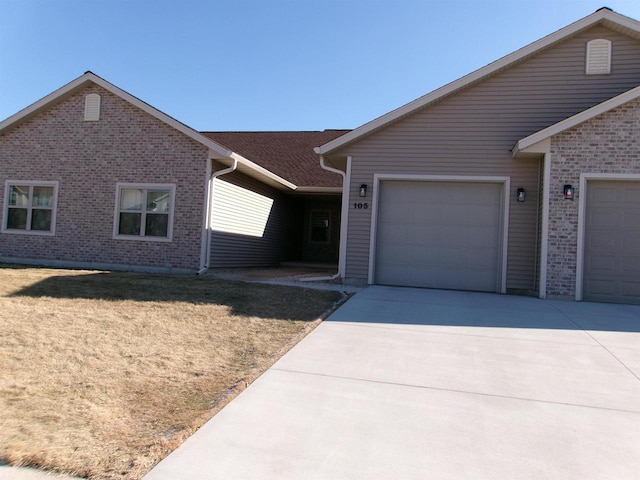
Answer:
367, 173, 511, 293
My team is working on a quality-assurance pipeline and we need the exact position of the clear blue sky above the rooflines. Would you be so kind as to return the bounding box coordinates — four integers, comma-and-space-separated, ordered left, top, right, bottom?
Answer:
0, 0, 640, 130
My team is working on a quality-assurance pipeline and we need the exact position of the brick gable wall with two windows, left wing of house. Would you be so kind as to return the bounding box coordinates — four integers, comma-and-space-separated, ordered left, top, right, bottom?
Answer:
0, 84, 208, 270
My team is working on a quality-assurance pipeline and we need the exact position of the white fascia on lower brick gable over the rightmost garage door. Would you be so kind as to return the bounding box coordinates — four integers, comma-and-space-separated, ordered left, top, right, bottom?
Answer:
513, 83, 640, 157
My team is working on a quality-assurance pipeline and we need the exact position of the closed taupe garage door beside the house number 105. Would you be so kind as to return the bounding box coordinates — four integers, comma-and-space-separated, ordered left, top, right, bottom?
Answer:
374, 181, 503, 292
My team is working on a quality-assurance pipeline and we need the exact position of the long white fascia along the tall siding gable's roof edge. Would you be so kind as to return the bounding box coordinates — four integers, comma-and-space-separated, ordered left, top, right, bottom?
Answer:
315, 9, 640, 155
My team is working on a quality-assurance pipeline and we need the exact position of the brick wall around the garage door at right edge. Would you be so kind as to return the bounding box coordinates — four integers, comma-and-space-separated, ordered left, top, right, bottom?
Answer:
547, 96, 640, 297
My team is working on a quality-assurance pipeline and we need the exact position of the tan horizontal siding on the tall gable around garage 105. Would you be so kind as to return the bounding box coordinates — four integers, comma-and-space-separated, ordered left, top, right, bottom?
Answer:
337, 26, 640, 290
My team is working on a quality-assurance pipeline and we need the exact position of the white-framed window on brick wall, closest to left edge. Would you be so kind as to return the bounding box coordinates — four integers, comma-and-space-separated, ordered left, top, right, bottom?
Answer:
2, 180, 58, 235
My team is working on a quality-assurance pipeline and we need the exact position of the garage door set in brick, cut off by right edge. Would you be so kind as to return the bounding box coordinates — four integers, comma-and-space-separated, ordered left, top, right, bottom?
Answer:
583, 181, 640, 303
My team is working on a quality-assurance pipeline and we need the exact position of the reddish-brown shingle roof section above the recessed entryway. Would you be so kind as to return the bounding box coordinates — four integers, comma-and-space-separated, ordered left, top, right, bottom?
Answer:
200, 130, 349, 187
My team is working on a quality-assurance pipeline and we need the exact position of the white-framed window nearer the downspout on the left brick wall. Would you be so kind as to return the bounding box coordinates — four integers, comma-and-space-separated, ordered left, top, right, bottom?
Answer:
114, 183, 175, 241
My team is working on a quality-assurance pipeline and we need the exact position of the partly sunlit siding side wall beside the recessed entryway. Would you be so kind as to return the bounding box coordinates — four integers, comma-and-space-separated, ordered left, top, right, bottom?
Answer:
210, 172, 293, 268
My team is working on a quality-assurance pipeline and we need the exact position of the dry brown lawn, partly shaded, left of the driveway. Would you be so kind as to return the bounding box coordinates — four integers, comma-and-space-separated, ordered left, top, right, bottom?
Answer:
0, 264, 342, 479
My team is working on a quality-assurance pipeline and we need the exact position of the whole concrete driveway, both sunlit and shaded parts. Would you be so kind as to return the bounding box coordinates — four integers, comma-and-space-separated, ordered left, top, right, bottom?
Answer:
145, 286, 640, 480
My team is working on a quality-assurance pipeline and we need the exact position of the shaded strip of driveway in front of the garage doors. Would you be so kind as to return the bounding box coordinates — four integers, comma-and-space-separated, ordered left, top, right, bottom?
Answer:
329, 286, 640, 334
